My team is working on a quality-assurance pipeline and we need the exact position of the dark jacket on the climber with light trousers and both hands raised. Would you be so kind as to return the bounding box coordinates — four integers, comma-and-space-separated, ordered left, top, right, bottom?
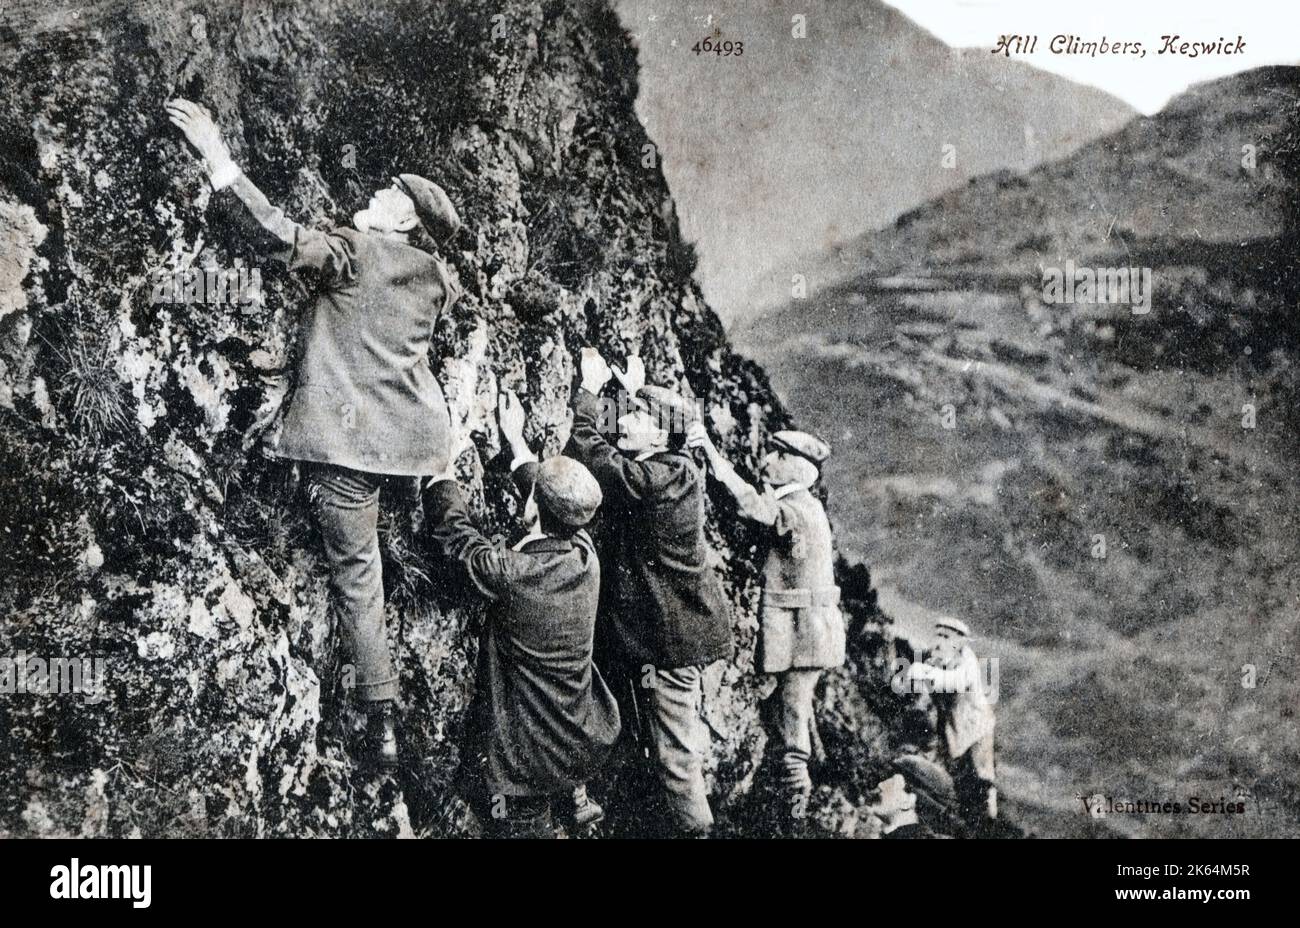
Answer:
567, 390, 733, 669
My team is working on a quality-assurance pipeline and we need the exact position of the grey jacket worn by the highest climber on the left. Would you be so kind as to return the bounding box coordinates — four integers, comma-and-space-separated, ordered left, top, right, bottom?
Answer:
230, 175, 455, 476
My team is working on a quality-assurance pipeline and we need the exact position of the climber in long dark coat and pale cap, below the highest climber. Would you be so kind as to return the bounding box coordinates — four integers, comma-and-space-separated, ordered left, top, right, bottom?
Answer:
424, 393, 619, 837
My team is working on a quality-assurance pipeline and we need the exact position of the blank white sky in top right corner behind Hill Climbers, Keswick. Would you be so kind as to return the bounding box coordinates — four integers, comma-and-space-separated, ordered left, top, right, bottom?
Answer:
885, 0, 1300, 114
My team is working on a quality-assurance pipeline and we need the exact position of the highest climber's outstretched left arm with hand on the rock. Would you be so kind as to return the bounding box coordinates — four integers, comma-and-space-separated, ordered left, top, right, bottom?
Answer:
166, 99, 354, 279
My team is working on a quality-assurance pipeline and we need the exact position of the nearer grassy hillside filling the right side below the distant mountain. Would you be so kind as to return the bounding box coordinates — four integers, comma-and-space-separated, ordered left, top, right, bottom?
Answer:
735, 68, 1300, 836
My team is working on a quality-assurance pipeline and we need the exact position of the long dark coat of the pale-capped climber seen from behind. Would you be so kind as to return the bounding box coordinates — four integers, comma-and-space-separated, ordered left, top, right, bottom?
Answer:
424, 464, 619, 795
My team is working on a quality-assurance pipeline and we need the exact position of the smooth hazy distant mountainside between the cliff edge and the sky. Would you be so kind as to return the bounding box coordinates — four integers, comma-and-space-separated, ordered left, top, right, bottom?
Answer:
618, 0, 1134, 325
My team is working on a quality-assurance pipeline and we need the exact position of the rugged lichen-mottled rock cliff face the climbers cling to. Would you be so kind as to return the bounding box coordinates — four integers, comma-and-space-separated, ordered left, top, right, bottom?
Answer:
0, 0, 881, 836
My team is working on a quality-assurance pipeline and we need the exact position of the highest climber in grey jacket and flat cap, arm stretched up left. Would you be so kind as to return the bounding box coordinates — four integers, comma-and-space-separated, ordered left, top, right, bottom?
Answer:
166, 99, 460, 766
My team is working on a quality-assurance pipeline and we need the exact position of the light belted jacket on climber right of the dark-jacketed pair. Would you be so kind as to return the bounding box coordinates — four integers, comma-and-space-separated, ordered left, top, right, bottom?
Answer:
715, 460, 845, 673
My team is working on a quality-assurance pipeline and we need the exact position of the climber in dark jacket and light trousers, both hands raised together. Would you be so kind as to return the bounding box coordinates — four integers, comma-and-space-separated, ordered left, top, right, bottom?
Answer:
568, 348, 733, 836
